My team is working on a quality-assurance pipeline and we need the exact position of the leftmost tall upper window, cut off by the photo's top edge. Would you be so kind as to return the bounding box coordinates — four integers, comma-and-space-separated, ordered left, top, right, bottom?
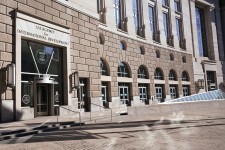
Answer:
97, 0, 106, 23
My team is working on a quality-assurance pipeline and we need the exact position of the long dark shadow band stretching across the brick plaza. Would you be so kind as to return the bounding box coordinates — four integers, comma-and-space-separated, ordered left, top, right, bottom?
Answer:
19, 118, 225, 143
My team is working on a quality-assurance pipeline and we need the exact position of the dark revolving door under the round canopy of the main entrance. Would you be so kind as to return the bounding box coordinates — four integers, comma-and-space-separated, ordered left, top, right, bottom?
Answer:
37, 85, 50, 116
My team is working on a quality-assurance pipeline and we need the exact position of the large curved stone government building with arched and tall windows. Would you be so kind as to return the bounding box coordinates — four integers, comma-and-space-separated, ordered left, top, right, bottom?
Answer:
0, 0, 225, 122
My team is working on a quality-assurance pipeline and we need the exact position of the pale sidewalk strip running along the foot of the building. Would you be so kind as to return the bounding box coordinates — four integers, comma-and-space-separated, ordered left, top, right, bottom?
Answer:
0, 105, 225, 135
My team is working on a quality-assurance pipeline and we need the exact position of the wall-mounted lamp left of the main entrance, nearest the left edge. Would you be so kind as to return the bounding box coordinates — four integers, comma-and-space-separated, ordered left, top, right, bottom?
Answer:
7, 64, 16, 87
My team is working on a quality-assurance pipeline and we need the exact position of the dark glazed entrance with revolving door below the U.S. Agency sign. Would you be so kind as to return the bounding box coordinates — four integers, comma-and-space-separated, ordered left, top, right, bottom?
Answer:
21, 40, 66, 117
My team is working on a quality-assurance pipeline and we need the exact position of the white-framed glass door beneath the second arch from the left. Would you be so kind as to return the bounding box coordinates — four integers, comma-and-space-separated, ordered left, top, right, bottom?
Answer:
119, 83, 129, 105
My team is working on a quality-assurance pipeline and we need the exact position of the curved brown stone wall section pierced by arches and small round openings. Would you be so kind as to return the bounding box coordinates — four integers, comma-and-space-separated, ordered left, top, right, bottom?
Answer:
99, 29, 195, 101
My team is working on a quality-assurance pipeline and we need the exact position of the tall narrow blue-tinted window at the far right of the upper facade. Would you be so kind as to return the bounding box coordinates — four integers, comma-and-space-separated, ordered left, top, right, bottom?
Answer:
195, 7, 208, 57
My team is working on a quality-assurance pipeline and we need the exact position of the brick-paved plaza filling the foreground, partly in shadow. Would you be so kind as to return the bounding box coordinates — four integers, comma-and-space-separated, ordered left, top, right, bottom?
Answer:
0, 109, 225, 150
